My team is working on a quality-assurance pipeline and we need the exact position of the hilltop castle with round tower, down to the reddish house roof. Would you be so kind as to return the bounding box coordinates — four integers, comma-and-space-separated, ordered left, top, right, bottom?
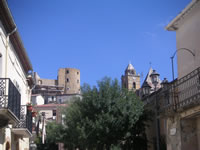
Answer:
32, 68, 81, 105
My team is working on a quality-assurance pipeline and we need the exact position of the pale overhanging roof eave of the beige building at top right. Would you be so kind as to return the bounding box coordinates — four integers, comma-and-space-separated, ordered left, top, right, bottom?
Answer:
165, 0, 200, 31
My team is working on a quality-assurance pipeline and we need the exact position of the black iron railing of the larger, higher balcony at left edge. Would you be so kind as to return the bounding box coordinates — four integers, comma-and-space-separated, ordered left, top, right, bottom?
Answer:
0, 78, 21, 119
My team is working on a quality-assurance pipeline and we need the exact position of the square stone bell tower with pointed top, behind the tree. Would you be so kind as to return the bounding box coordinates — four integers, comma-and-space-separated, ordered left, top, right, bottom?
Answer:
121, 63, 140, 91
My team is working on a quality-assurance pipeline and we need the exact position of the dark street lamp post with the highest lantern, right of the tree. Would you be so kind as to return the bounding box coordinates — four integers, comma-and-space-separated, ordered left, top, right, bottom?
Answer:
150, 70, 160, 150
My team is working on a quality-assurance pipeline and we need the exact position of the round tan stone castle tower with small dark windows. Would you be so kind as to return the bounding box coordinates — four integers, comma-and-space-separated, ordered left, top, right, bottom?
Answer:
58, 68, 80, 94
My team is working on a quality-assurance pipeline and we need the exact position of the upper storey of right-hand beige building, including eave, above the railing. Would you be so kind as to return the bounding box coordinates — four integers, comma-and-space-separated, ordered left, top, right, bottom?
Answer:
166, 0, 200, 78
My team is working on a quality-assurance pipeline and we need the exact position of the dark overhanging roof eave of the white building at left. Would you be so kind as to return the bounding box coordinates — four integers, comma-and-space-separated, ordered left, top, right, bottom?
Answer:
0, 0, 33, 73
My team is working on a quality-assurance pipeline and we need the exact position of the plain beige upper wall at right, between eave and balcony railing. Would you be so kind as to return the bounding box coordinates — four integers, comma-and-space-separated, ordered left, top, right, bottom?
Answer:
176, 2, 200, 78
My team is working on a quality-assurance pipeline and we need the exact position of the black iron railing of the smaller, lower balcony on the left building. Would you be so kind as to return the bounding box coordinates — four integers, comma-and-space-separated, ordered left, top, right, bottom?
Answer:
15, 105, 32, 133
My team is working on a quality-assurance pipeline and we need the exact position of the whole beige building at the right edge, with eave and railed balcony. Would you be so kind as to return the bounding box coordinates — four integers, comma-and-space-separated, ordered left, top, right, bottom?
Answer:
163, 0, 200, 150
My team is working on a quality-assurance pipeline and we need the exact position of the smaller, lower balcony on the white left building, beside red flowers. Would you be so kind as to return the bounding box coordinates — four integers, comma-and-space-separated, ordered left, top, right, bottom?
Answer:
12, 105, 32, 138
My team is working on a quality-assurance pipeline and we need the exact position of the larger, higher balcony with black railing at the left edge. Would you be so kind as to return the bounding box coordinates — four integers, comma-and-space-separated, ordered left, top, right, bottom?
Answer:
0, 78, 21, 128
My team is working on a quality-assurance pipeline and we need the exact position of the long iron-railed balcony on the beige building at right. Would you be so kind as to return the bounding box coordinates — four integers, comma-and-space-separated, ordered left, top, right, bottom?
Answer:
160, 67, 200, 112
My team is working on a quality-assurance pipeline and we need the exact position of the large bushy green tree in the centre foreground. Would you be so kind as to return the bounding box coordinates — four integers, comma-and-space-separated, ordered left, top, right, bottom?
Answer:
62, 77, 147, 150
